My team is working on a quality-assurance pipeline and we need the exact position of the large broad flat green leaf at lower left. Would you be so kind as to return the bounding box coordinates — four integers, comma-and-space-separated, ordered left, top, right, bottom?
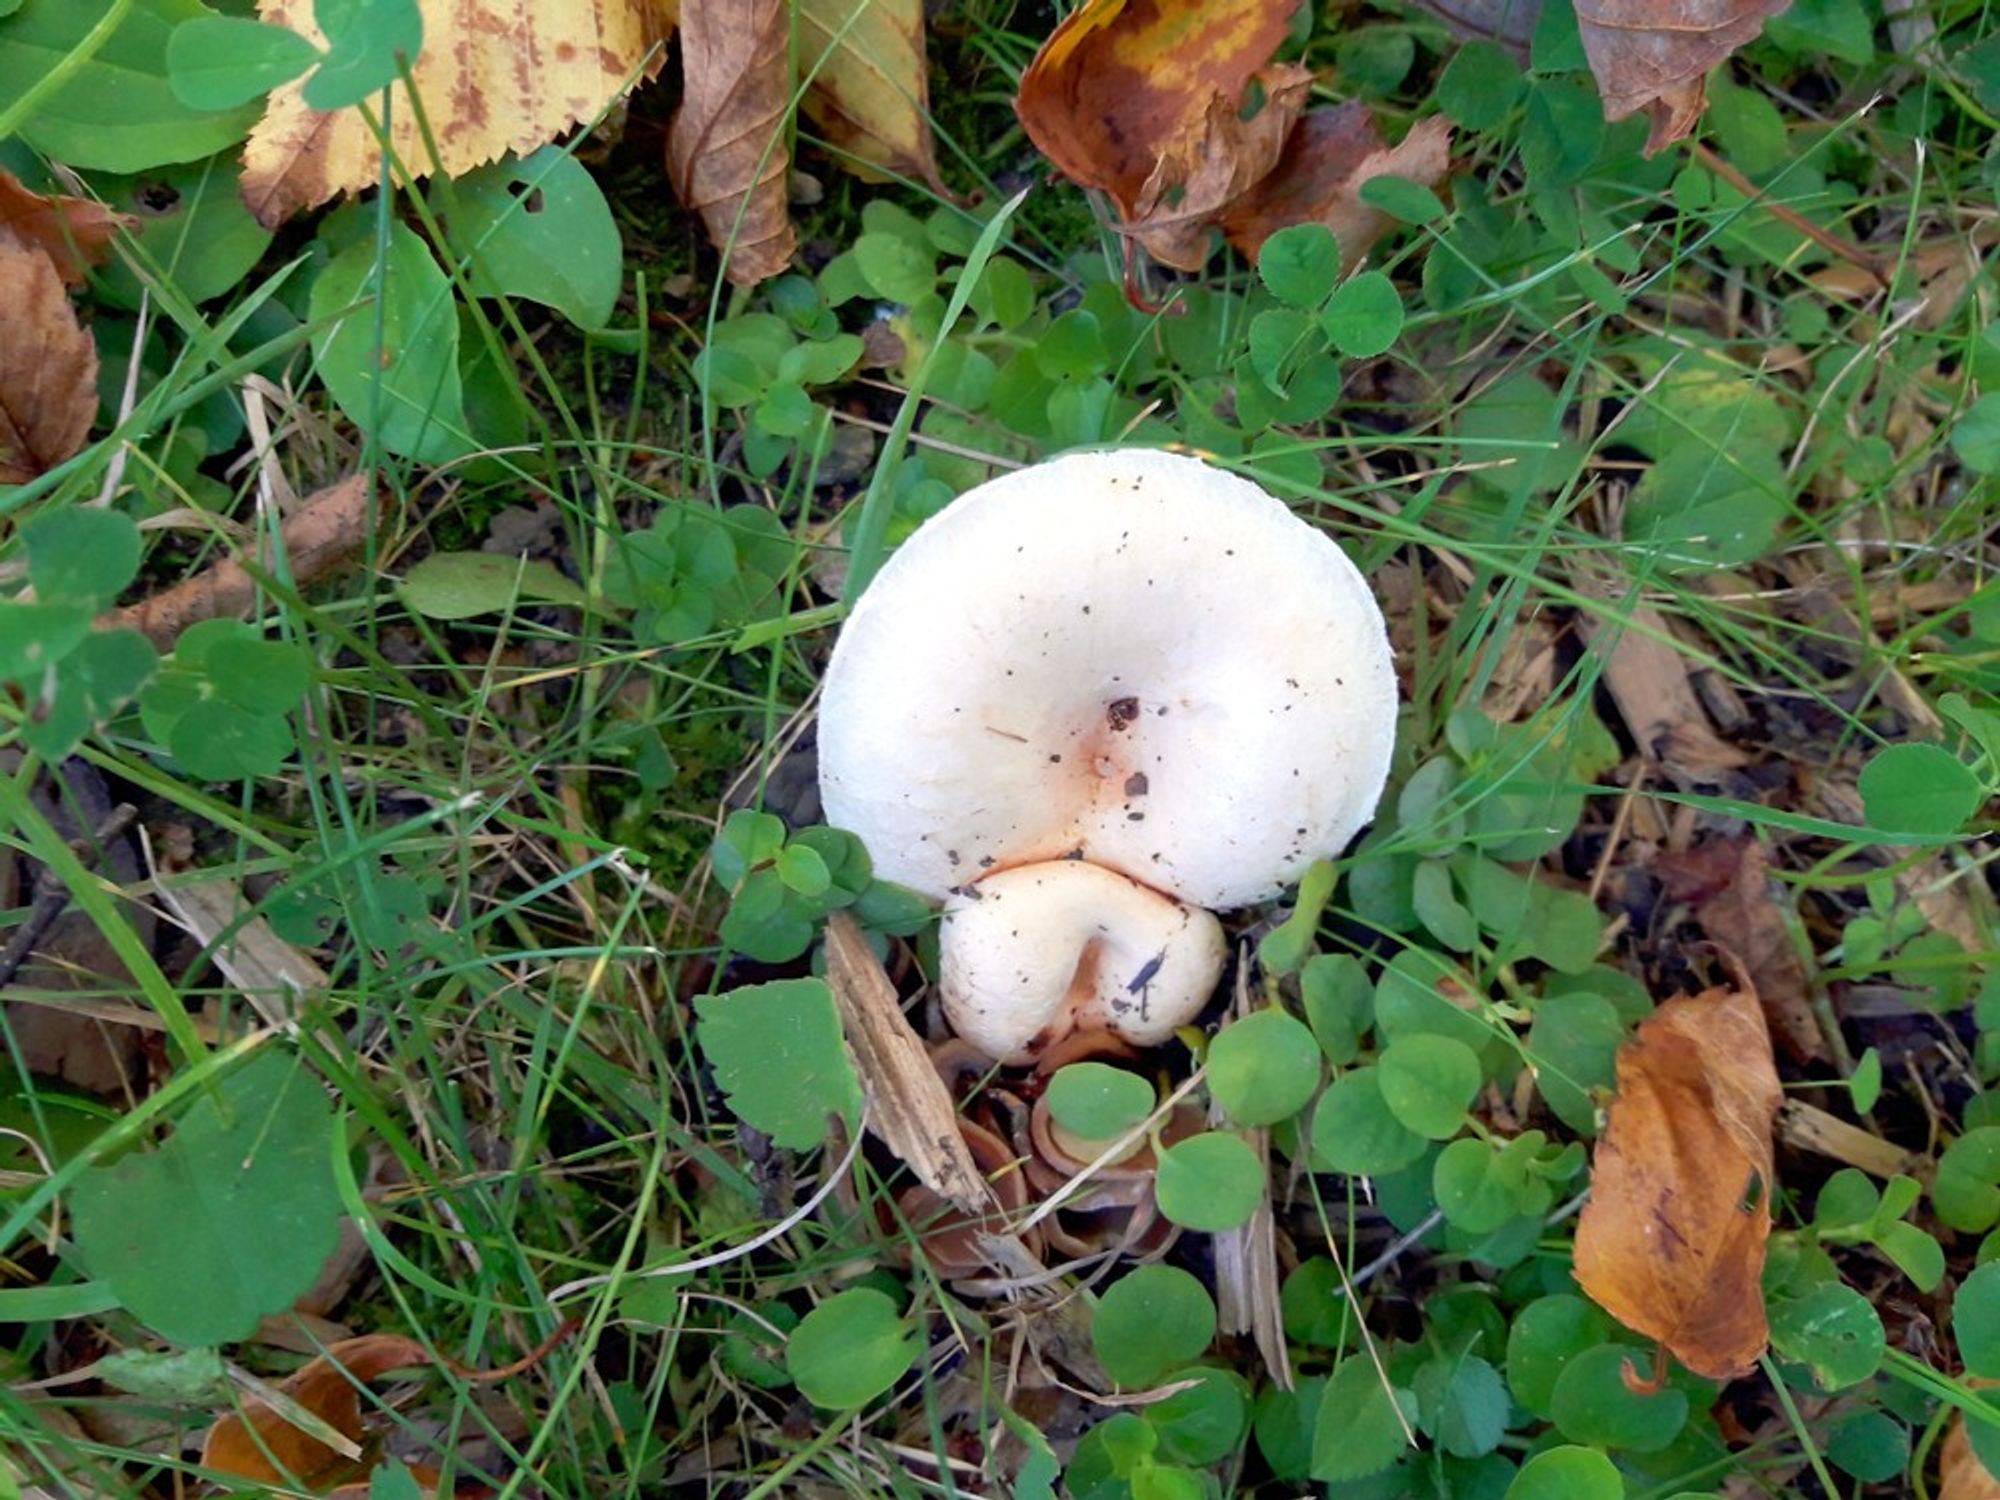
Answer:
70, 1048, 342, 1346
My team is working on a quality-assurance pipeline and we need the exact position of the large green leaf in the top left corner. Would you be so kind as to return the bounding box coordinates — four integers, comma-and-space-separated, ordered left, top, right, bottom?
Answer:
0, 0, 256, 172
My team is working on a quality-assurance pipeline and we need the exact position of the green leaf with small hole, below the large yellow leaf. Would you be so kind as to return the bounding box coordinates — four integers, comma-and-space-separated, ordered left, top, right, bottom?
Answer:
434, 146, 624, 328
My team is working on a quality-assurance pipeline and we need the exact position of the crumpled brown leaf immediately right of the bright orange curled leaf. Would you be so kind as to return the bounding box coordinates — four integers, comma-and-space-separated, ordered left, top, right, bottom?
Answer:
1222, 102, 1452, 268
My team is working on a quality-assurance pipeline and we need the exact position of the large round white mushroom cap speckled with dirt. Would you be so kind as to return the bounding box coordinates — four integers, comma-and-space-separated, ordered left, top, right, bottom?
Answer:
820, 450, 1396, 908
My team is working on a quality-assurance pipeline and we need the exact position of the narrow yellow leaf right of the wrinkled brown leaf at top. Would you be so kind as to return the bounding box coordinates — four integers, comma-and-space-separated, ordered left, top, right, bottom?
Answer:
798, 0, 944, 192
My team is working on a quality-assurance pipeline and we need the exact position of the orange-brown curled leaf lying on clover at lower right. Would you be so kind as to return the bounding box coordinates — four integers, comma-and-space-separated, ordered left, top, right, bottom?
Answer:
1576, 990, 1780, 1380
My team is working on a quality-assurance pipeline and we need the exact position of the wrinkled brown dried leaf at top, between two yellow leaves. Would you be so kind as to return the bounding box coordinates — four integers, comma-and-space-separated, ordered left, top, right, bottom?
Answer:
666, 0, 798, 286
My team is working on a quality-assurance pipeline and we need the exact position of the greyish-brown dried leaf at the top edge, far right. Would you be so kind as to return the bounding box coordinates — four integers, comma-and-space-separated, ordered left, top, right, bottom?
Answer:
1576, 0, 1792, 156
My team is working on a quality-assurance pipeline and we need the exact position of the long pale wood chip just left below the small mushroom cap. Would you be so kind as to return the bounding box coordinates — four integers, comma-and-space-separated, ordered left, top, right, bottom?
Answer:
826, 912, 992, 1214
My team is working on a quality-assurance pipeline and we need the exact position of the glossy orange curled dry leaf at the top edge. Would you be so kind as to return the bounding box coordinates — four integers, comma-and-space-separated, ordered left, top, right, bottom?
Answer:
1014, 0, 1312, 270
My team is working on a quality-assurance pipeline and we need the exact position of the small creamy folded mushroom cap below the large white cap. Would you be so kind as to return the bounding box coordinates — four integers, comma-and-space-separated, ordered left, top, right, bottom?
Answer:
938, 860, 1228, 1062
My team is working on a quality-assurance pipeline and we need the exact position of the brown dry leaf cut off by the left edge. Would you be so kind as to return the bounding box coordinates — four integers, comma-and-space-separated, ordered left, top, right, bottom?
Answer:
0, 234, 98, 484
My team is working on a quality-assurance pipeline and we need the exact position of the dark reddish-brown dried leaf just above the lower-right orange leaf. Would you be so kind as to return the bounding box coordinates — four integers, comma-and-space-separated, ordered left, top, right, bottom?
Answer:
1654, 838, 1826, 1060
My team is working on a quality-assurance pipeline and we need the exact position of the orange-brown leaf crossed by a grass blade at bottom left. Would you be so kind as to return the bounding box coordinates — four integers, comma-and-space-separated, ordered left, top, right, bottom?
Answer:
202, 1334, 432, 1484
